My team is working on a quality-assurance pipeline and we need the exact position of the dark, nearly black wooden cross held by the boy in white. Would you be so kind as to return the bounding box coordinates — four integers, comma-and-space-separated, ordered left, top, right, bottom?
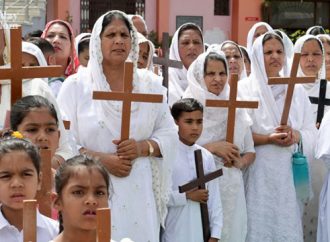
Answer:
179, 150, 222, 242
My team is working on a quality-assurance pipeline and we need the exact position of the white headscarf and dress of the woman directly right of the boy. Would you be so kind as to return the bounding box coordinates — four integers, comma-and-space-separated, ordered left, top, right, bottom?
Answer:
183, 52, 254, 242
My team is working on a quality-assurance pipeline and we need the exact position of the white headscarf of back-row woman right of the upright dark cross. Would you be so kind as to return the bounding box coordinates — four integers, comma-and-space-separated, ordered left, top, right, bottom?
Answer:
169, 23, 205, 90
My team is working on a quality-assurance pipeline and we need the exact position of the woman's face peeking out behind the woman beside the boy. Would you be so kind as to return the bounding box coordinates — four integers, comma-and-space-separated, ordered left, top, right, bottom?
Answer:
221, 43, 243, 75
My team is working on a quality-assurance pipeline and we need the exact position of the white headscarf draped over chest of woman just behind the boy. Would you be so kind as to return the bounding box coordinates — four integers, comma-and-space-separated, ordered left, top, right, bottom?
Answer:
183, 51, 251, 149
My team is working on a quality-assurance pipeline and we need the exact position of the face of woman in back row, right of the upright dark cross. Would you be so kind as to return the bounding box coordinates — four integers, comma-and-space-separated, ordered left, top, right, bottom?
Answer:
179, 29, 204, 69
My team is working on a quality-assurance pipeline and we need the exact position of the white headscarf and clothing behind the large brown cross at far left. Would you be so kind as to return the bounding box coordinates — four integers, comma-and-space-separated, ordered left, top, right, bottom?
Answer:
0, 42, 77, 160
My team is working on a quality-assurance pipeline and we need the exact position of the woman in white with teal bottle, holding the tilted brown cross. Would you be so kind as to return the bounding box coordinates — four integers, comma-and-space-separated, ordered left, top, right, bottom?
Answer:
240, 33, 316, 242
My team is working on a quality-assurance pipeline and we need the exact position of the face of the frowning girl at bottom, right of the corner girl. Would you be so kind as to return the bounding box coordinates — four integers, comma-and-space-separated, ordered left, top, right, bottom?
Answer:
55, 166, 108, 230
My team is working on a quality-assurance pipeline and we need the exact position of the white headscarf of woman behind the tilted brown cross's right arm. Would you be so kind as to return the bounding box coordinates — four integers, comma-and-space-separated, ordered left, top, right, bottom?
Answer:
294, 35, 326, 92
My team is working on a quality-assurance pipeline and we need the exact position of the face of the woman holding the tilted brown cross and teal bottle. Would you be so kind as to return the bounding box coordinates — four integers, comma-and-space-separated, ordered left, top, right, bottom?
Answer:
263, 39, 284, 77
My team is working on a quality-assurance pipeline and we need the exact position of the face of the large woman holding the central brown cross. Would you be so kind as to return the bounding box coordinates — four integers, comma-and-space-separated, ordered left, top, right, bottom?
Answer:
101, 19, 131, 65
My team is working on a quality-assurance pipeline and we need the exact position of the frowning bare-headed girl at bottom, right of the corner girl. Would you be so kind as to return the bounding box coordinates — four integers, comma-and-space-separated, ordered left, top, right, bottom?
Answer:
53, 155, 131, 242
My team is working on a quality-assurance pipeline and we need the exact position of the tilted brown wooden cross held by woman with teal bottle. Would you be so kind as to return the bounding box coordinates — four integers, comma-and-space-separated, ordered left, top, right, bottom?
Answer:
268, 53, 316, 125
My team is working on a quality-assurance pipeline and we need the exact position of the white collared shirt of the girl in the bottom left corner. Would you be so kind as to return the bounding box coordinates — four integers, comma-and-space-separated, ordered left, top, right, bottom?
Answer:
0, 210, 59, 242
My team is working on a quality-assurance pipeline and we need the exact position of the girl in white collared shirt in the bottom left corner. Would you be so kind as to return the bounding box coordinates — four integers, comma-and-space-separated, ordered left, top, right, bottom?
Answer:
0, 137, 58, 242
